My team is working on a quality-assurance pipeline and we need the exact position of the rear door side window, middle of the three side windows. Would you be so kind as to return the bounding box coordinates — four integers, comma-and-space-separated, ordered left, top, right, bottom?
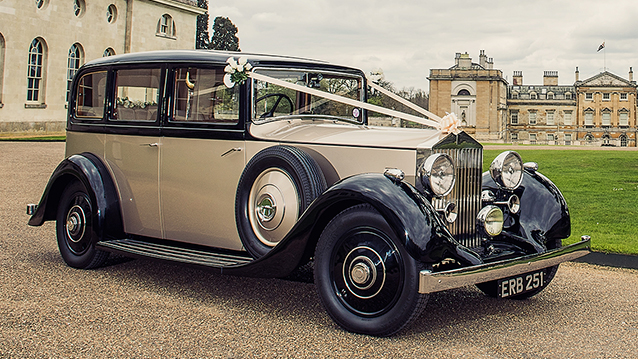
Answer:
112, 69, 161, 122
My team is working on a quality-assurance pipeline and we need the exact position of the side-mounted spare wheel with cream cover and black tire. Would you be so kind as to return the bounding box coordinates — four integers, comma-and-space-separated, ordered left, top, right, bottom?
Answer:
235, 146, 326, 258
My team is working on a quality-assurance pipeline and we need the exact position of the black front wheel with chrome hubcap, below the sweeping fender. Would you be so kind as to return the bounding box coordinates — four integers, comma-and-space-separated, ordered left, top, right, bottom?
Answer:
314, 204, 428, 336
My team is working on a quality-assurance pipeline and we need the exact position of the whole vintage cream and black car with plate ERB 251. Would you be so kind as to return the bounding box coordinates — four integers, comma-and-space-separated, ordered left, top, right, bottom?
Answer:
28, 51, 590, 336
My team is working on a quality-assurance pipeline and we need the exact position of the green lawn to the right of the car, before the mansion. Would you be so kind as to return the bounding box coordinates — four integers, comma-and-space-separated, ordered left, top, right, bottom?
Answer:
483, 149, 638, 254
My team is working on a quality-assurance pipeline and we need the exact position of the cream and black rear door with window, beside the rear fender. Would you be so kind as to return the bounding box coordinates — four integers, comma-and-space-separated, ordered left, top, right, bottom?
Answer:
104, 66, 163, 238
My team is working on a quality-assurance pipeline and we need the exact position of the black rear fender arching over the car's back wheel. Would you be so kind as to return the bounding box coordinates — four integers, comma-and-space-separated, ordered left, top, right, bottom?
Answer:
29, 153, 123, 242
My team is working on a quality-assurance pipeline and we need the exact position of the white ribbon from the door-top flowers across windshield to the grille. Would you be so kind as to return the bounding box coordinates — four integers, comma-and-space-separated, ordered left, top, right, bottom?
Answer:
248, 72, 441, 129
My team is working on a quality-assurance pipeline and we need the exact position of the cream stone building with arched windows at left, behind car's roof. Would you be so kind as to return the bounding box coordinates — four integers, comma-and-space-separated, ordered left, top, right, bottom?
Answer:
0, 0, 205, 134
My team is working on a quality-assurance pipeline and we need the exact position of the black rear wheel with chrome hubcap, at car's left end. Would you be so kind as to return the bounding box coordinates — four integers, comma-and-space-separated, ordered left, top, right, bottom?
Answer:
56, 181, 109, 269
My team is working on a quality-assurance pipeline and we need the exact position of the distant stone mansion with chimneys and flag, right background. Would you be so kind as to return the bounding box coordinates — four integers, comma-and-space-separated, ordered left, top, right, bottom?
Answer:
428, 51, 638, 147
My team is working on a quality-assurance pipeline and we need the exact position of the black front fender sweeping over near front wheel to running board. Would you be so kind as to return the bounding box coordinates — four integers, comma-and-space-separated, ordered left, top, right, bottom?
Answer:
222, 174, 482, 277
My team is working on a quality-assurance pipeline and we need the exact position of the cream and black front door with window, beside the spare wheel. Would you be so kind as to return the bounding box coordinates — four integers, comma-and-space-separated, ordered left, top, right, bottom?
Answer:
159, 65, 246, 250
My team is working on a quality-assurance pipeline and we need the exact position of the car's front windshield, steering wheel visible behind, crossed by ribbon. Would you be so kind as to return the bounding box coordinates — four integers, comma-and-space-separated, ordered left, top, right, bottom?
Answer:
253, 70, 364, 122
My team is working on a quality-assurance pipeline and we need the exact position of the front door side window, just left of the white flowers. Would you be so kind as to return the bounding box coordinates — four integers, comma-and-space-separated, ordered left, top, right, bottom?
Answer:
171, 67, 239, 124
